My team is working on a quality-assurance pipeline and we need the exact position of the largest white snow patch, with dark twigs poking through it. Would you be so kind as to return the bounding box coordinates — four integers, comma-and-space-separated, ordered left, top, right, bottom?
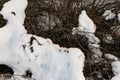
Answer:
0, 0, 85, 80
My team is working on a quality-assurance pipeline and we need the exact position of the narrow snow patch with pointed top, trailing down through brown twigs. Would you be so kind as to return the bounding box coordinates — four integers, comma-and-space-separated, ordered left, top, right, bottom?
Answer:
72, 10, 102, 62
